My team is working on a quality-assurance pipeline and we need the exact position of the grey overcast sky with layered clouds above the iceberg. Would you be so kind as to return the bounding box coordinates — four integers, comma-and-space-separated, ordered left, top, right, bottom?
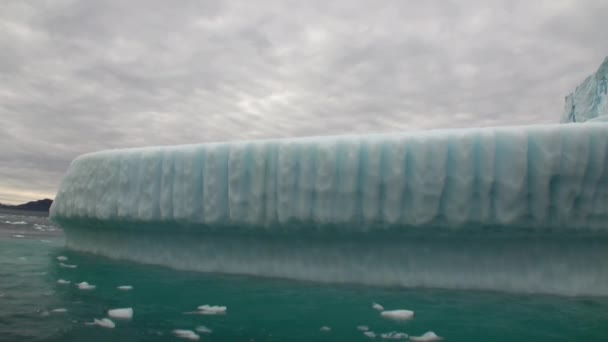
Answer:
0, 0, 608, 203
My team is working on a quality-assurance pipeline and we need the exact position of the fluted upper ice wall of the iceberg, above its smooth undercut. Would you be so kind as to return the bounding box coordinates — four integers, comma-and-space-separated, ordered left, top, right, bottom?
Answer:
51, 122, 608, 233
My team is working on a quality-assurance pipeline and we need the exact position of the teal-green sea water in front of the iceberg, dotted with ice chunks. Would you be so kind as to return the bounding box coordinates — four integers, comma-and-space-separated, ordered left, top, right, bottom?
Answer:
0, 211, 608, 342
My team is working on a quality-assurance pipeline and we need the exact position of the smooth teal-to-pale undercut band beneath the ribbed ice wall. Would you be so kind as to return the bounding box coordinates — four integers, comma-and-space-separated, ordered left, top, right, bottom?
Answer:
66, 224, 608, 295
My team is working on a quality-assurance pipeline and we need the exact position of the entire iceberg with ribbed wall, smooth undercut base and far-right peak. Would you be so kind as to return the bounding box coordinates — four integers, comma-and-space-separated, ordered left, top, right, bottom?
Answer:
51, 58, 608, 296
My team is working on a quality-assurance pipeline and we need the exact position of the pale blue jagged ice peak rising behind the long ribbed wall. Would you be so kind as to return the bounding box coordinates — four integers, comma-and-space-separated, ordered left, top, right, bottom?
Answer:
561, 57, 608, 122
